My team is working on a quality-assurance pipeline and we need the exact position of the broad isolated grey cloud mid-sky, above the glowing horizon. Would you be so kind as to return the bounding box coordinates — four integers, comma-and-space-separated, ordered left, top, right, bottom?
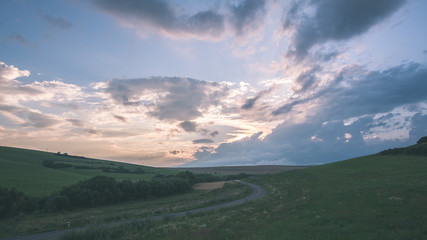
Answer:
106, 77, 228, 121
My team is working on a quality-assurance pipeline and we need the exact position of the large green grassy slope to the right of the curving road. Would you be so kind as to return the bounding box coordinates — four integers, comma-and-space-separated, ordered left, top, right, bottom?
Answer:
62, 143, 427, 240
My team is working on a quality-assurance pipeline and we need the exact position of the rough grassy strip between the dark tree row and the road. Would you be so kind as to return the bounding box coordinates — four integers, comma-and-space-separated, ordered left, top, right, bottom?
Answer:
0, 182, 251, 239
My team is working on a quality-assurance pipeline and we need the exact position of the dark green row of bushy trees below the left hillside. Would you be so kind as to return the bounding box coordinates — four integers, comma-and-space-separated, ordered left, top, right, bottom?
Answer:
0, 171, 248, 218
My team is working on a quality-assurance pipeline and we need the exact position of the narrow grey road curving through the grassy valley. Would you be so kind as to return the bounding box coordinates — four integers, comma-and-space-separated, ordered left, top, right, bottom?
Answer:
0, 180, 266, 240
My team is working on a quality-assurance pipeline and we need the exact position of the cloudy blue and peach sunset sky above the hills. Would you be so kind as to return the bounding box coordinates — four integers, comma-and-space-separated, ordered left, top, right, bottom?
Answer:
0, 0, 427, 167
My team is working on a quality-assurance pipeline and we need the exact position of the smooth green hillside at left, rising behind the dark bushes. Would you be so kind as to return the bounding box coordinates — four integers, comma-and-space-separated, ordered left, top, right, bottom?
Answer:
0, 147, 176, 196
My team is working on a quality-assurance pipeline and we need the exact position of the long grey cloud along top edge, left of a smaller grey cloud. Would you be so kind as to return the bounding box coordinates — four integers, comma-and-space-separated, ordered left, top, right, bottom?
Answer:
95, 0, 224, 37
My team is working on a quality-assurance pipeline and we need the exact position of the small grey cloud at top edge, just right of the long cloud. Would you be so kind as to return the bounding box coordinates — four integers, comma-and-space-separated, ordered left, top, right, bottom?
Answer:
230, 0, 265, 35
